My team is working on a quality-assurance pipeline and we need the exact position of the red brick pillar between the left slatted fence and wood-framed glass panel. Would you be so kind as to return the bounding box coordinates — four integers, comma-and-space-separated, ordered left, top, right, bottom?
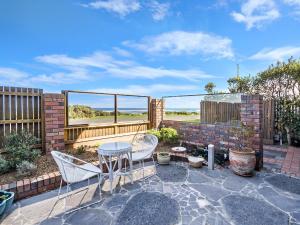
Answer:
44, 94, 65, 154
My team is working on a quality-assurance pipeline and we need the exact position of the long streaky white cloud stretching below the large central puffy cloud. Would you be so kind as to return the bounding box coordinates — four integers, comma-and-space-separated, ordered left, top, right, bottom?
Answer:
36, 52, 214, 80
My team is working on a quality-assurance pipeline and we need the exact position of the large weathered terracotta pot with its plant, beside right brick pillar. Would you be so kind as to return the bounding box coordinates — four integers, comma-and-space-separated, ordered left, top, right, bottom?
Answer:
229, 123, 256, 176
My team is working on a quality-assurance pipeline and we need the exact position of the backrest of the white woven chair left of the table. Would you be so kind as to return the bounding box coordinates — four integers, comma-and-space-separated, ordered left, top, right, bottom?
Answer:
51, 151, 91, 183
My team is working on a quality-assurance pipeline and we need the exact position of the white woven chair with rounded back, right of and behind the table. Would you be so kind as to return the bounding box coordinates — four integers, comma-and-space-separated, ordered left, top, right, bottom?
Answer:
125, 134, 158, 179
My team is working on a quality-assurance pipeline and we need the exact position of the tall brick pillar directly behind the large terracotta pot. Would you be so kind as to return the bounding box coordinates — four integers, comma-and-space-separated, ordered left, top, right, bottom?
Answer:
241, 95, 263, 170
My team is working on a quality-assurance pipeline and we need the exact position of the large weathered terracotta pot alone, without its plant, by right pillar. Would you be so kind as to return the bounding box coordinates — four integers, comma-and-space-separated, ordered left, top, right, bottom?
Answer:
229, 149, 256, 176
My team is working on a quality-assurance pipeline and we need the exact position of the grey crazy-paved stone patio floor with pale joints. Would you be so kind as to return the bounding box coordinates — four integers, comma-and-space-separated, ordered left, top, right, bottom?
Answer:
1, 162, 300, 225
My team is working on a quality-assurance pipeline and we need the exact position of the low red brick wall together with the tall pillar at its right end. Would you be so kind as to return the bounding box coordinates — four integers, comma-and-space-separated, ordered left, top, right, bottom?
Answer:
161, 95, 263, 170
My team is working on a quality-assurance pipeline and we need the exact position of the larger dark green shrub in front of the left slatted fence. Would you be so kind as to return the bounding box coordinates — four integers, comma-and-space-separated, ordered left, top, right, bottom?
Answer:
4, 131, 40, 168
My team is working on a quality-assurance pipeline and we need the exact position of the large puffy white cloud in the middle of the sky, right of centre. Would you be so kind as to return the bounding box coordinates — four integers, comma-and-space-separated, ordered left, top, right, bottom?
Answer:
123, 31, 234, 58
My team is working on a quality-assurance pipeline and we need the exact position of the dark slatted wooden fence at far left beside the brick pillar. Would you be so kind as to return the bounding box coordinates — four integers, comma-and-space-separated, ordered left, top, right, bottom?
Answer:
0, 86, 44, 149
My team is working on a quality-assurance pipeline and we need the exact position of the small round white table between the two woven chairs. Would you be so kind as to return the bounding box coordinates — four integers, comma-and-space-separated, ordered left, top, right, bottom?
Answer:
97, 142, 133, 193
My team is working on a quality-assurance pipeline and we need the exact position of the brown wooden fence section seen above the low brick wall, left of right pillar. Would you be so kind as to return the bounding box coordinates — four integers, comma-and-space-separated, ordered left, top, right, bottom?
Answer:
200, 101, 241, 124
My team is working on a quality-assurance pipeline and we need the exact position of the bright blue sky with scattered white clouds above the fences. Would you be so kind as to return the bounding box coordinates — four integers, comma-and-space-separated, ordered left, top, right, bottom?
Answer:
0, 0, 300, 97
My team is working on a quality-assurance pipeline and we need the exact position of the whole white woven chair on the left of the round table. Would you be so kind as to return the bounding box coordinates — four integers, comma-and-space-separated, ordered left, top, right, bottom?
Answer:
51, 151, 102, 213
